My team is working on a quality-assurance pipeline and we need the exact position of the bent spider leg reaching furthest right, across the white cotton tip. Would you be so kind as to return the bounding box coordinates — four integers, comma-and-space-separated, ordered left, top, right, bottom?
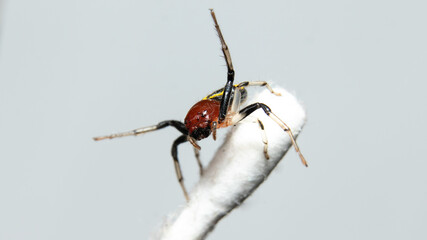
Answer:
233, 103, 308, 167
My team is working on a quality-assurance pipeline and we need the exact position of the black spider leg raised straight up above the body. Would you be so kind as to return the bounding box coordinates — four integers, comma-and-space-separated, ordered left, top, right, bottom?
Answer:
210, 9, 234, 123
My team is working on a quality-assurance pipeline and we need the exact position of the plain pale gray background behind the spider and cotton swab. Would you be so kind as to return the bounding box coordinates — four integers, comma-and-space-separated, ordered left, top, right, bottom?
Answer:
0, 0, 427, 240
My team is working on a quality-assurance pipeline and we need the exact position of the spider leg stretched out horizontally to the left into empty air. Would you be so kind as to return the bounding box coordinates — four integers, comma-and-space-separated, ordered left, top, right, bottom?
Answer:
93, 120, 188, 141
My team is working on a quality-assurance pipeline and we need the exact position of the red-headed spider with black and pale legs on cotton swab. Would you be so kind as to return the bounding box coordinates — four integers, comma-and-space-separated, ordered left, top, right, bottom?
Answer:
93, 9, 308, 201
